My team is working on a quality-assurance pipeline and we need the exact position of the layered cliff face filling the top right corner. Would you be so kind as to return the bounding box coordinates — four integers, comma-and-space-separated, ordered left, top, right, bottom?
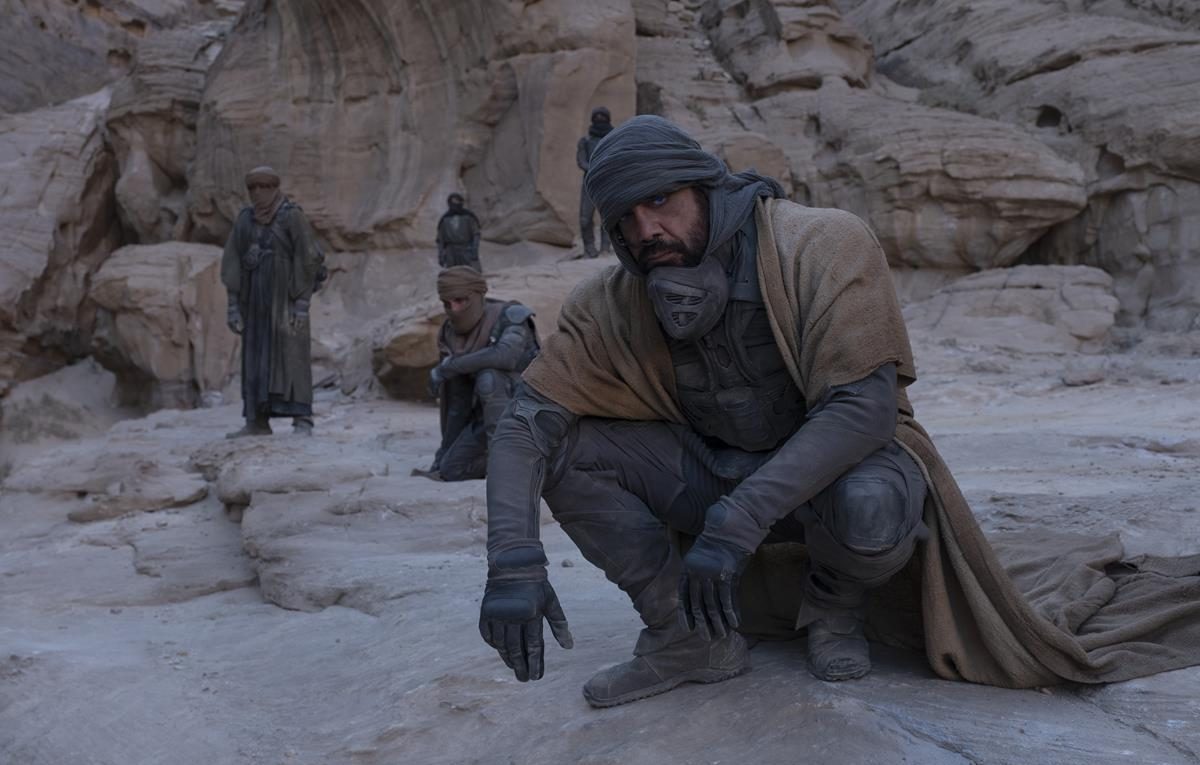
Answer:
842, 0, 1200, 330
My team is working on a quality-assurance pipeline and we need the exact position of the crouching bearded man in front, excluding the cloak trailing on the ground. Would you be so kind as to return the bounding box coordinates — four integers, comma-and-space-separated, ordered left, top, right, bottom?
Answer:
480, 116, 926, 706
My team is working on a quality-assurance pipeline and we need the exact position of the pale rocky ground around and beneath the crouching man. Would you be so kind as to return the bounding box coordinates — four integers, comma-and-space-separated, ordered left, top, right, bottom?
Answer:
0, 336, 1200, 765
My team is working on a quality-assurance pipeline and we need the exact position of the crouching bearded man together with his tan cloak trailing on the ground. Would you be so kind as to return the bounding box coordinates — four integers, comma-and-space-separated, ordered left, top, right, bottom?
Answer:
479, 115, 1200, 713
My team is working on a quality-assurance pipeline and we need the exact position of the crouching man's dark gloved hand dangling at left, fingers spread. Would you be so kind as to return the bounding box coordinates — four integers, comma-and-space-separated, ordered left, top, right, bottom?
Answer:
479, 568, 575, 682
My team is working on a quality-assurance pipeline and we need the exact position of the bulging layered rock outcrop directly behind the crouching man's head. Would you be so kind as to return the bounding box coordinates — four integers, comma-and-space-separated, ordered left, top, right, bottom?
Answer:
638, 0, 1086, 272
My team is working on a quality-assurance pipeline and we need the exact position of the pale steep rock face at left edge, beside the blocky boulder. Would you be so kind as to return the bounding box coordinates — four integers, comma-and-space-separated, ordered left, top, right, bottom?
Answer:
0, 90, 120, 396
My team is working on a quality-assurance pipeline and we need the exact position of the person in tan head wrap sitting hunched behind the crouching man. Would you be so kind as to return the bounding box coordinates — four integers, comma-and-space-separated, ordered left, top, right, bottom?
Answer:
415, 266, 539, 481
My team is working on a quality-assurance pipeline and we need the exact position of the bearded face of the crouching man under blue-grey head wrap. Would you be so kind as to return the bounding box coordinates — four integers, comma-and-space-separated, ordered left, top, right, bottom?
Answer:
617, 186, 708, 273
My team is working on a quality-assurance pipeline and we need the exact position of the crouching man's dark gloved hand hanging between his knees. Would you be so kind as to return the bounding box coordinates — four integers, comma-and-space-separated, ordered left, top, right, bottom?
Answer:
679, 498, 766, 640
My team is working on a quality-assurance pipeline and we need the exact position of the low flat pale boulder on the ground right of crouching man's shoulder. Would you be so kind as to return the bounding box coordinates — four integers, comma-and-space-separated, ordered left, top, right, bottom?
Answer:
904, 266, 1117, 353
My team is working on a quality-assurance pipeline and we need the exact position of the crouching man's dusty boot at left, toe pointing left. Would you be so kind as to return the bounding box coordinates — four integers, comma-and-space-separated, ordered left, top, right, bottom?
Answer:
583, 632, 750, 707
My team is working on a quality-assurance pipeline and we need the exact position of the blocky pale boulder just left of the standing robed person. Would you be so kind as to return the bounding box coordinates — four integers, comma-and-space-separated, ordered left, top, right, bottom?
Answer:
91, 242, 239, 406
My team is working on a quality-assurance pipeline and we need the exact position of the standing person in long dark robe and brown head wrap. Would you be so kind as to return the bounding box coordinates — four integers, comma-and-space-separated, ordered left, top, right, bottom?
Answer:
221, 167, 325, 438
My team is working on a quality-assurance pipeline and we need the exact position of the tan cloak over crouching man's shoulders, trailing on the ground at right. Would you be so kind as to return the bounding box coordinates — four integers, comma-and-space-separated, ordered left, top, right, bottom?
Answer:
524, 200, 1200, 687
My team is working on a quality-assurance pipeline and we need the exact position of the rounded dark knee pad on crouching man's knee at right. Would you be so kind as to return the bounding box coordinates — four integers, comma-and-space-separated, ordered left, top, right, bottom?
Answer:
826, 476, 912, 555
